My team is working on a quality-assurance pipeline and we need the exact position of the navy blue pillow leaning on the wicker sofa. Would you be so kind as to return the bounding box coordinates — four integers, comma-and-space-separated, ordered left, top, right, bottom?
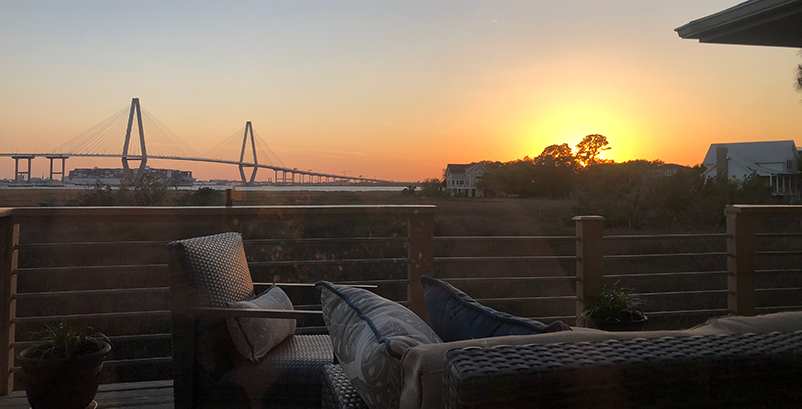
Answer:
420, 276, 571, 342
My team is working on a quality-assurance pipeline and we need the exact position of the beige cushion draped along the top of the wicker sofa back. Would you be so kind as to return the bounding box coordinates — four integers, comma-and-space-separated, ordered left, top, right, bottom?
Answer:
400, 312, 802, 409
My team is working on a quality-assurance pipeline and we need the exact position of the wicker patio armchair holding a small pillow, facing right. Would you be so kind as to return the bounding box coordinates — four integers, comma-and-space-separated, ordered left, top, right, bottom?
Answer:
169, 233, 334, 409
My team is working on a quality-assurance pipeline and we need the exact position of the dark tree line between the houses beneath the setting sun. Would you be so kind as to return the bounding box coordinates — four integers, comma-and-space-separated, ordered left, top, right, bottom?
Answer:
422, 134, 787, 228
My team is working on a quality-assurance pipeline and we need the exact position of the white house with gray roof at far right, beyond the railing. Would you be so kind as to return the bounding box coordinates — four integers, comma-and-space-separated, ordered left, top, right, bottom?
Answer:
702, 141, 800, 196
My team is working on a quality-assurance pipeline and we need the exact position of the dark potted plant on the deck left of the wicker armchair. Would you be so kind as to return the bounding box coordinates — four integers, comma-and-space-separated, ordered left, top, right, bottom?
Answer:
16, 322, 111, 409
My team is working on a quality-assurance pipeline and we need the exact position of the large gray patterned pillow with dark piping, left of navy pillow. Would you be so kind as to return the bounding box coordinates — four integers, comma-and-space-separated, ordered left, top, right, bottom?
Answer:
317, 282, 441, 409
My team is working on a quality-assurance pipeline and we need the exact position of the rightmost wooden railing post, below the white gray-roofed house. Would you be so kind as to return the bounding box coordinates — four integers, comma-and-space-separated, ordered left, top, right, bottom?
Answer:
726, 206, 756, 316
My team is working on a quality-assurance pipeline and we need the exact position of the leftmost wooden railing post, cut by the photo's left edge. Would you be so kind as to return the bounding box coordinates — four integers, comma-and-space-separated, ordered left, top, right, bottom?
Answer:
0, 216, 19, 395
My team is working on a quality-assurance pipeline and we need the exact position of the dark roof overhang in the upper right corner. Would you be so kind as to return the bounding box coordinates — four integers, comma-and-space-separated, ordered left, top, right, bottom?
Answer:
675, 0, 802, 48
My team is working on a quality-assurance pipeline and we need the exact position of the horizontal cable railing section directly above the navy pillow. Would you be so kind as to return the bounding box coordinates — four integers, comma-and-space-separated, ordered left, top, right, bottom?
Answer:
433, 235, 577, 323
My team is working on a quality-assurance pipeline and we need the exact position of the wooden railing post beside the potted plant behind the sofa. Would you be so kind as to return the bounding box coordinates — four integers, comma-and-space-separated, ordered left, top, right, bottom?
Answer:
573, 216, 604, 318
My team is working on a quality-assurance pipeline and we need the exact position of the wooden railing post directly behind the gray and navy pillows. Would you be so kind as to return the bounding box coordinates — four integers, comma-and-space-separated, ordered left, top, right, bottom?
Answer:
407, 213, 434, 323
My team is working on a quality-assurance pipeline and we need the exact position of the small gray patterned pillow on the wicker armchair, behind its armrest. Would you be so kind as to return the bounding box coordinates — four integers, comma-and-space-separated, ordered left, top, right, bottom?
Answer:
226, 286, 296, 362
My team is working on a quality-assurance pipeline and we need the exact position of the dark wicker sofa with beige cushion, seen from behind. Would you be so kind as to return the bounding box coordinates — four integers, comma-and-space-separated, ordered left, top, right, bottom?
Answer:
323, 312, 802, 409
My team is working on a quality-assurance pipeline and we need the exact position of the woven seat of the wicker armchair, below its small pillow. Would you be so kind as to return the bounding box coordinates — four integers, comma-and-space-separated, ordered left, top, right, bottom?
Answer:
219, 335, 334, 408
